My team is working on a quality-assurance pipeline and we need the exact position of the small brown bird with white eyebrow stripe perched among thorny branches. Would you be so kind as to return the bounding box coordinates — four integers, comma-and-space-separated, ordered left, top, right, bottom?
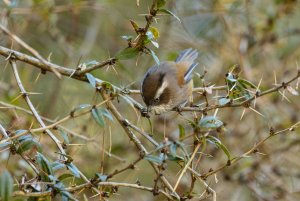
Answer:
141, 48, 198, 114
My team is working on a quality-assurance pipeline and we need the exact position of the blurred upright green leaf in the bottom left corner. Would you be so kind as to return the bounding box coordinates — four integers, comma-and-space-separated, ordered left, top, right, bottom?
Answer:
0, 170, 13, 201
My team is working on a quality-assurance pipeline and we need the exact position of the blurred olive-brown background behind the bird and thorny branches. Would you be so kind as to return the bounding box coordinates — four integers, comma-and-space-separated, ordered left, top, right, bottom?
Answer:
0, 0, 300, 201
